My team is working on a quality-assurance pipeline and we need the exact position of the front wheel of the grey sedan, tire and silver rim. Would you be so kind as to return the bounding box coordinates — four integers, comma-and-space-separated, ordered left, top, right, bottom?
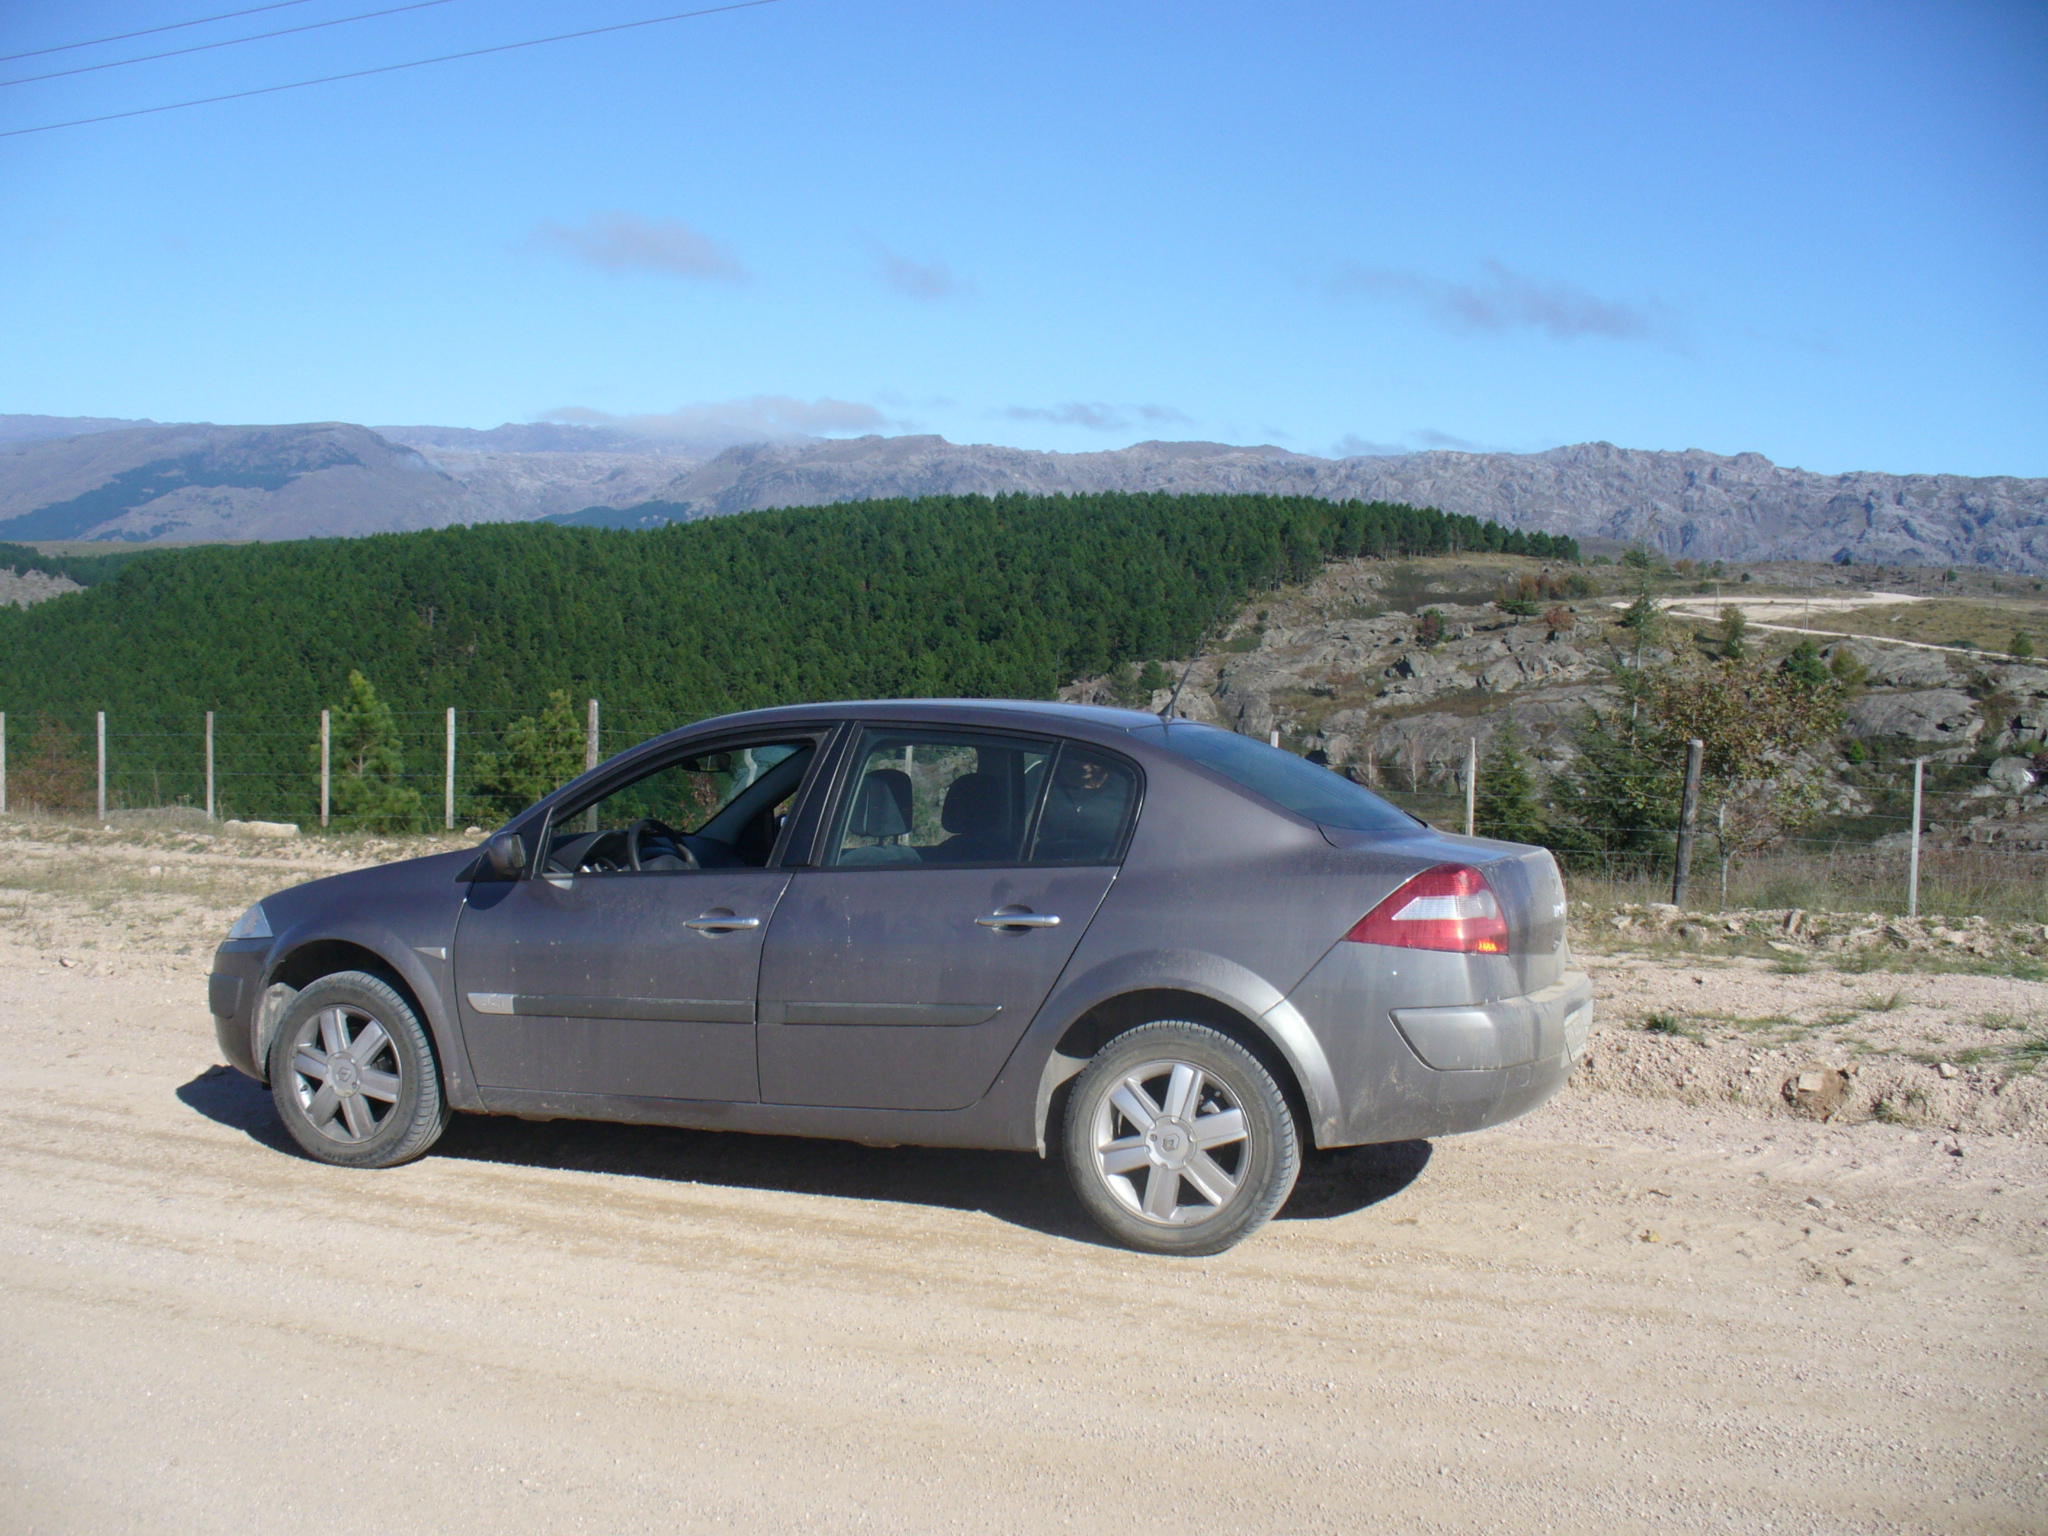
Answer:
270, 971, 451, 1167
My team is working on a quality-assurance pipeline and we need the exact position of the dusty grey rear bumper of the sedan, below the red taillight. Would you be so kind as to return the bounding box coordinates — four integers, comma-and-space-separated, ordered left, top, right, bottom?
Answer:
1290, 944, 1593, 1147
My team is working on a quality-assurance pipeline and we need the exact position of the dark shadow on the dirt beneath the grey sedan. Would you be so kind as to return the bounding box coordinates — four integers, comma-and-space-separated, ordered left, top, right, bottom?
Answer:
178, 1067, 1430, 1245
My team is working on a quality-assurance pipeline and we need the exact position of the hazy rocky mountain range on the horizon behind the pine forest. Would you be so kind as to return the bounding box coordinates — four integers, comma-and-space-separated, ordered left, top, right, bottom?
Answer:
0, 416, 2048, 573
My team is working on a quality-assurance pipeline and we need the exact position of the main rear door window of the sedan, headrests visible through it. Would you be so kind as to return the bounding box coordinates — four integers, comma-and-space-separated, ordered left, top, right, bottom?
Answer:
825, 727, 1053, 868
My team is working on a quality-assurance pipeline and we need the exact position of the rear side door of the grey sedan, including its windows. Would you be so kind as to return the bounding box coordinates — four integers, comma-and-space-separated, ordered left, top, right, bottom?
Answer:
758, 727, 1141, 1110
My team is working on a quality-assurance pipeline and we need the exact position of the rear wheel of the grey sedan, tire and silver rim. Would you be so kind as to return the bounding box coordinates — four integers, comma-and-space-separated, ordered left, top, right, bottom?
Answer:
1065, 1020, 1300, 1253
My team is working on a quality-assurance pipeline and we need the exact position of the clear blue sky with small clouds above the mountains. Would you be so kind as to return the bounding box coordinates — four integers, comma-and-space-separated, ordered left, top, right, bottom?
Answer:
0, 0, 2048, 475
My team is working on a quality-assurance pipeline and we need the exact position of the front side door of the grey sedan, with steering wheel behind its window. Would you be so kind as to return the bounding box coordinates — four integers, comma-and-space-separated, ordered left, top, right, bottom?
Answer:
455, 733, 821, 1102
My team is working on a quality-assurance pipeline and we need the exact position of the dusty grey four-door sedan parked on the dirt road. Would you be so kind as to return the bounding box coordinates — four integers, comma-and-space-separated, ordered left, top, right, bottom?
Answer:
211, 700, 1593, 1253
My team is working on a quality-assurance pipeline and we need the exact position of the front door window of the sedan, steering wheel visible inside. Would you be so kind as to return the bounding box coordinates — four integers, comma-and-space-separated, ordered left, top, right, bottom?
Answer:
543, 739, 817, 874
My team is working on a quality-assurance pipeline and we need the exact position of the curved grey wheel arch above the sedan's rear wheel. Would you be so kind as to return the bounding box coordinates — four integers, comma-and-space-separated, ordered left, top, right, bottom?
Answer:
1019, 950, 1343, 1153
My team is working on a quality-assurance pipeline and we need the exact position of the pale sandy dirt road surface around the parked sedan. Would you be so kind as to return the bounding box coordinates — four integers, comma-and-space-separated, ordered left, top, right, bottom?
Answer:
0, 821, 2048, 1532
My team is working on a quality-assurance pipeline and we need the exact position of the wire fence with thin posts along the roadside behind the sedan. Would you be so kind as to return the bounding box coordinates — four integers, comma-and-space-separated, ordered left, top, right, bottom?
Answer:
0, 700, 2048, 920
